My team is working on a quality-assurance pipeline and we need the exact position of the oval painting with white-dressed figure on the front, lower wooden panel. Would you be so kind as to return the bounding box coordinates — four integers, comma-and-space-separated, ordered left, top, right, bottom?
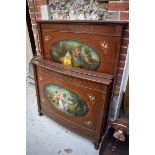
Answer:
44, 84, 88, 116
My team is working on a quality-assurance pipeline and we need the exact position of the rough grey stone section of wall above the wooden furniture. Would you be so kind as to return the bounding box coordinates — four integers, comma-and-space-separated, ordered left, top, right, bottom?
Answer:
48, 0, 112, 20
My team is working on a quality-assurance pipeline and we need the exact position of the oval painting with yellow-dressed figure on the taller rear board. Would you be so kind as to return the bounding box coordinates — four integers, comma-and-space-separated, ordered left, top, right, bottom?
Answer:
50, 40, 100, 71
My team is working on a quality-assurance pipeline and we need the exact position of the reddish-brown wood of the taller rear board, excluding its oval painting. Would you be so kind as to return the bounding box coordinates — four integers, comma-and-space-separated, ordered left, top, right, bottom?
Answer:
37, 21, 127, 74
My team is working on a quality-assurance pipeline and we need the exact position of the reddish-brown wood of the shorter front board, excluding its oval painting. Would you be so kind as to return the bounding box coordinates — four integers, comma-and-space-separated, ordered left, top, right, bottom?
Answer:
33, 58, 113, 146
